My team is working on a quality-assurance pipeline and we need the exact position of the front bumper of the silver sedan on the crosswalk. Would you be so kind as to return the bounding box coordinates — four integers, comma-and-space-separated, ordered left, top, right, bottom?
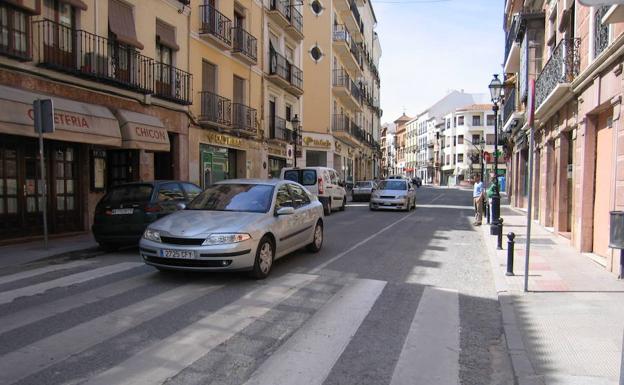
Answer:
139, 238, 258, 271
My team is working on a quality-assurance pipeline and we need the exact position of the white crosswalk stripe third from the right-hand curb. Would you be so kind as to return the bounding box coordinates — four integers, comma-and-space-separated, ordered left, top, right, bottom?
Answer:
81, 274, 316, 385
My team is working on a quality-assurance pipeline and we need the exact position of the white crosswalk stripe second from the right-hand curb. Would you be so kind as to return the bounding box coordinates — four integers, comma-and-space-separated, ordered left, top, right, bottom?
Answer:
246, 279, 386, 385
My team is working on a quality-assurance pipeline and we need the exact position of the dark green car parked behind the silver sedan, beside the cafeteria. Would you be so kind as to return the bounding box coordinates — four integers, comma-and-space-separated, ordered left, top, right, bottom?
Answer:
91, 180, 202, 250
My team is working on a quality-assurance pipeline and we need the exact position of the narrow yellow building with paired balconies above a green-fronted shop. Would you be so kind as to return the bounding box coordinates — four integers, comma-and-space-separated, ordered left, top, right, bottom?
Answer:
188, 0, 264, 187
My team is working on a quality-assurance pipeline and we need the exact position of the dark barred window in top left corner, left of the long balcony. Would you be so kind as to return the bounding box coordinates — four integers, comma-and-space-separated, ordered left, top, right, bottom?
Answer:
0, 4, 30, 59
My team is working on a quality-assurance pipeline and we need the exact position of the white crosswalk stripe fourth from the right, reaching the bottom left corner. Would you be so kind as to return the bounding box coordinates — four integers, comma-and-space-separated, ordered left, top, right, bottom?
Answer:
0, 284, 220, 384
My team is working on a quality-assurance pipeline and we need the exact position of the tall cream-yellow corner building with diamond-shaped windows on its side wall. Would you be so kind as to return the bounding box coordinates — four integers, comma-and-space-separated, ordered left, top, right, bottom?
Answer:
301, 0, 381, 181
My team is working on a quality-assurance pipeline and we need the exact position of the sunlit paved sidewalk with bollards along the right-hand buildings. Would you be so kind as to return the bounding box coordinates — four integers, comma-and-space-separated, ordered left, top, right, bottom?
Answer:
482, 207, 624, 385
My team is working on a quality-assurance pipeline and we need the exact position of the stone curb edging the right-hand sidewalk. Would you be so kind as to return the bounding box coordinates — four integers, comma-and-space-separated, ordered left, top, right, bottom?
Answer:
481, 225, 546, 385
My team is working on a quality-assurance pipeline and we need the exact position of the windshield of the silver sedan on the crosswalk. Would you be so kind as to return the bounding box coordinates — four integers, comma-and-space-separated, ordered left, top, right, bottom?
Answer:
187, 184, 273, 213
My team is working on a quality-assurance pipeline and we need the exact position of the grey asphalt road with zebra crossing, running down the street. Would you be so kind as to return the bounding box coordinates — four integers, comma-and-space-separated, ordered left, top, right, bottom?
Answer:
0, 187, 514, 385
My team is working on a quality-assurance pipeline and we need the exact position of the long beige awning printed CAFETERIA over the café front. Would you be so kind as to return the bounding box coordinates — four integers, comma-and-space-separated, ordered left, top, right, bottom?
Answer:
0, 86, 121, 147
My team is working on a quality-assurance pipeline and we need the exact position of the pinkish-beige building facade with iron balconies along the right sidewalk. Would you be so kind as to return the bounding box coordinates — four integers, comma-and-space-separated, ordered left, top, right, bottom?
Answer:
503, 0, 624, 272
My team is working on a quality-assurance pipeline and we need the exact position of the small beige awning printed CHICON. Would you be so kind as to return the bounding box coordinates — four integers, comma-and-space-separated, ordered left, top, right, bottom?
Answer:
115, 110, 170, 151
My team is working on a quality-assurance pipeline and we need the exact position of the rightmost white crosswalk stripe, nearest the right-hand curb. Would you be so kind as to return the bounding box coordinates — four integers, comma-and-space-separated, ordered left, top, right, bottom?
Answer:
390, 287, 459, 385
